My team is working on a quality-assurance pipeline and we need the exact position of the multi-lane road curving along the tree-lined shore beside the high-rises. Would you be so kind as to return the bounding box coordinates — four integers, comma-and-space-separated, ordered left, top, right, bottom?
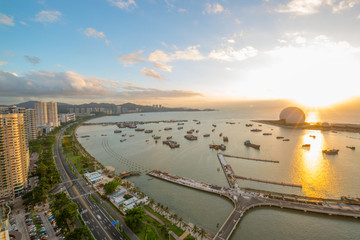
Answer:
54, 134, 125, 240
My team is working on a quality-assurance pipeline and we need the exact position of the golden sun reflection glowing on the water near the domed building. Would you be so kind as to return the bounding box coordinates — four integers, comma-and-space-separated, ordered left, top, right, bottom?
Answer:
297, 131, 336, 197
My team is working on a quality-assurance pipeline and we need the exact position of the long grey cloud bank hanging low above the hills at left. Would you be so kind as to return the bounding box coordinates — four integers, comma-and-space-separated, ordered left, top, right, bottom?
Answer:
0, 70, 202, 100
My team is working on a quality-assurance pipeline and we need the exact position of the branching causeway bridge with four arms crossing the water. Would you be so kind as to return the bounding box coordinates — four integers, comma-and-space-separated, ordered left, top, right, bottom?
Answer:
147, 153, 360, 240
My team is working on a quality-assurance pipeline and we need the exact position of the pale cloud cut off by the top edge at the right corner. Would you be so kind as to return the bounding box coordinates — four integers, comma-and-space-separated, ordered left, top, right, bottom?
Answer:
276, 0, 360, 15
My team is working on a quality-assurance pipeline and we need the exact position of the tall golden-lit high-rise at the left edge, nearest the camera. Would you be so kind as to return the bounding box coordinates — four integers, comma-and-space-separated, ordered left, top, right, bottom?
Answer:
0, 113, 29, 198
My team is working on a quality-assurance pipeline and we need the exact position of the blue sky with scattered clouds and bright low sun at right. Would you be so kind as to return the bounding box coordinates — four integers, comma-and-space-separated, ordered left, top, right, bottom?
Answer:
0, 0, 360, 107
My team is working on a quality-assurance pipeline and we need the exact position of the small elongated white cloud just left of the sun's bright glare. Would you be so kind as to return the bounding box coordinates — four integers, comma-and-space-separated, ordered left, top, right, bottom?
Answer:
209, 46, 258, 61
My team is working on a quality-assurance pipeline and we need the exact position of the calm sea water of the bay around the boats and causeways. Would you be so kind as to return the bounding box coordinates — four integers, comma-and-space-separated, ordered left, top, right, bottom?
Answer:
77, 110, 360, 240
